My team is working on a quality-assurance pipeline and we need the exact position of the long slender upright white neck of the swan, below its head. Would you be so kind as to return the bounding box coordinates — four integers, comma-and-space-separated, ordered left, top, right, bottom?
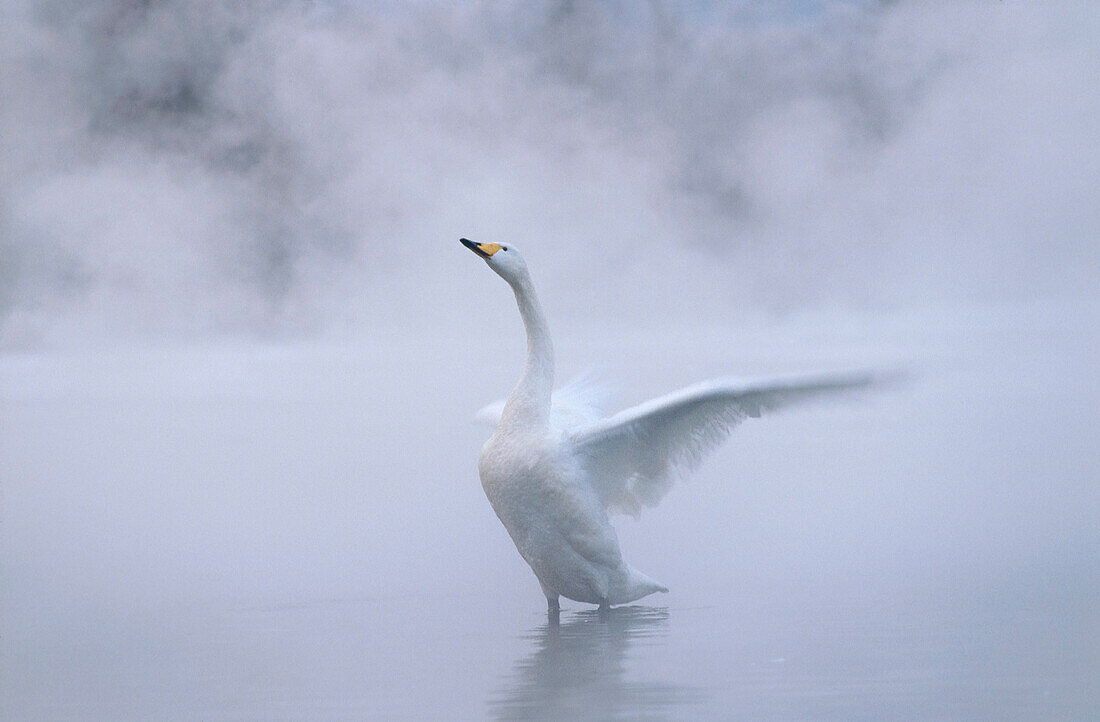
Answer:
501, 271, 553, 429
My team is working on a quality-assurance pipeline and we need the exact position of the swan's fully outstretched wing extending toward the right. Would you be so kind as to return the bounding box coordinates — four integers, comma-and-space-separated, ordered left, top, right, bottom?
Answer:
572, 372, 879, 516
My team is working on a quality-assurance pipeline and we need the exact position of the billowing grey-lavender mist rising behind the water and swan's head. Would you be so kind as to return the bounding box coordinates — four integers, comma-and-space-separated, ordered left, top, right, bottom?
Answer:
0, 2, 1100, 348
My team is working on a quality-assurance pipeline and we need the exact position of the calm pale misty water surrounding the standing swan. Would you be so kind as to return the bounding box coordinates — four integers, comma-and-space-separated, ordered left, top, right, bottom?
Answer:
0, 303, 1100, 720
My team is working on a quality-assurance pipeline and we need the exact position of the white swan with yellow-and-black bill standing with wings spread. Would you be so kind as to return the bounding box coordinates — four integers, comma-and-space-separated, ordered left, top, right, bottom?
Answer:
459, 238, 875, 613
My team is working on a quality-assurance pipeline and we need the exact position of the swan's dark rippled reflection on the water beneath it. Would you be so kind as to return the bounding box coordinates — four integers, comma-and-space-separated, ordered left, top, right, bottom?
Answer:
490, 606, 701, 720
